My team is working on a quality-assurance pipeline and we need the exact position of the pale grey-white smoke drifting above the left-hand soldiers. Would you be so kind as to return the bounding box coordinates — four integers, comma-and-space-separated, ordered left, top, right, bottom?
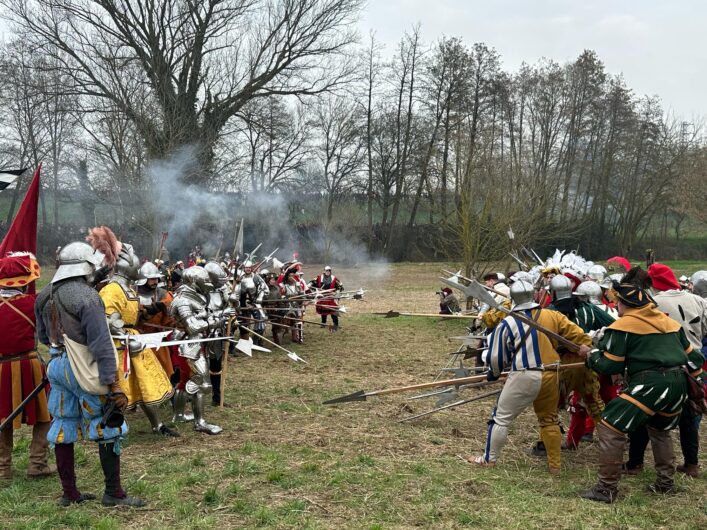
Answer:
147, 147, 388, 278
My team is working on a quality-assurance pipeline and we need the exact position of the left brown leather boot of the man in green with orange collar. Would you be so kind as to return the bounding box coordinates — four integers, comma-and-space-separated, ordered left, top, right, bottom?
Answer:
580, 423, 626, 504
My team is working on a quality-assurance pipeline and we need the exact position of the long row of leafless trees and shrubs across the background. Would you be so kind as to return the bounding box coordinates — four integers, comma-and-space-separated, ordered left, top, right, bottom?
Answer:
0, 0, 707, 267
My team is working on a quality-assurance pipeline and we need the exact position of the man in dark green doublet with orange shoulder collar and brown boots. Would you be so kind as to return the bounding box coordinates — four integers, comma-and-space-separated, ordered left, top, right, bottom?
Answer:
582, 268, 703, 503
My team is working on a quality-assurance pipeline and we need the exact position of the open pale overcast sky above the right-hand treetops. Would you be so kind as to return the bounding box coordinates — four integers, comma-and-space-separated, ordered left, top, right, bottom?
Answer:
360, 0, 707, 119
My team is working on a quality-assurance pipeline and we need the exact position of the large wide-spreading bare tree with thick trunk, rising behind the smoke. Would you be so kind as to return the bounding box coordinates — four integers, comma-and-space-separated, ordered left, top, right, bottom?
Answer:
6, 0, 361, 182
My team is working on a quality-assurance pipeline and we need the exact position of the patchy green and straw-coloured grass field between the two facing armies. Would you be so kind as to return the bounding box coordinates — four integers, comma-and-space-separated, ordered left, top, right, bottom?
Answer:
0, 264, 707, 530
